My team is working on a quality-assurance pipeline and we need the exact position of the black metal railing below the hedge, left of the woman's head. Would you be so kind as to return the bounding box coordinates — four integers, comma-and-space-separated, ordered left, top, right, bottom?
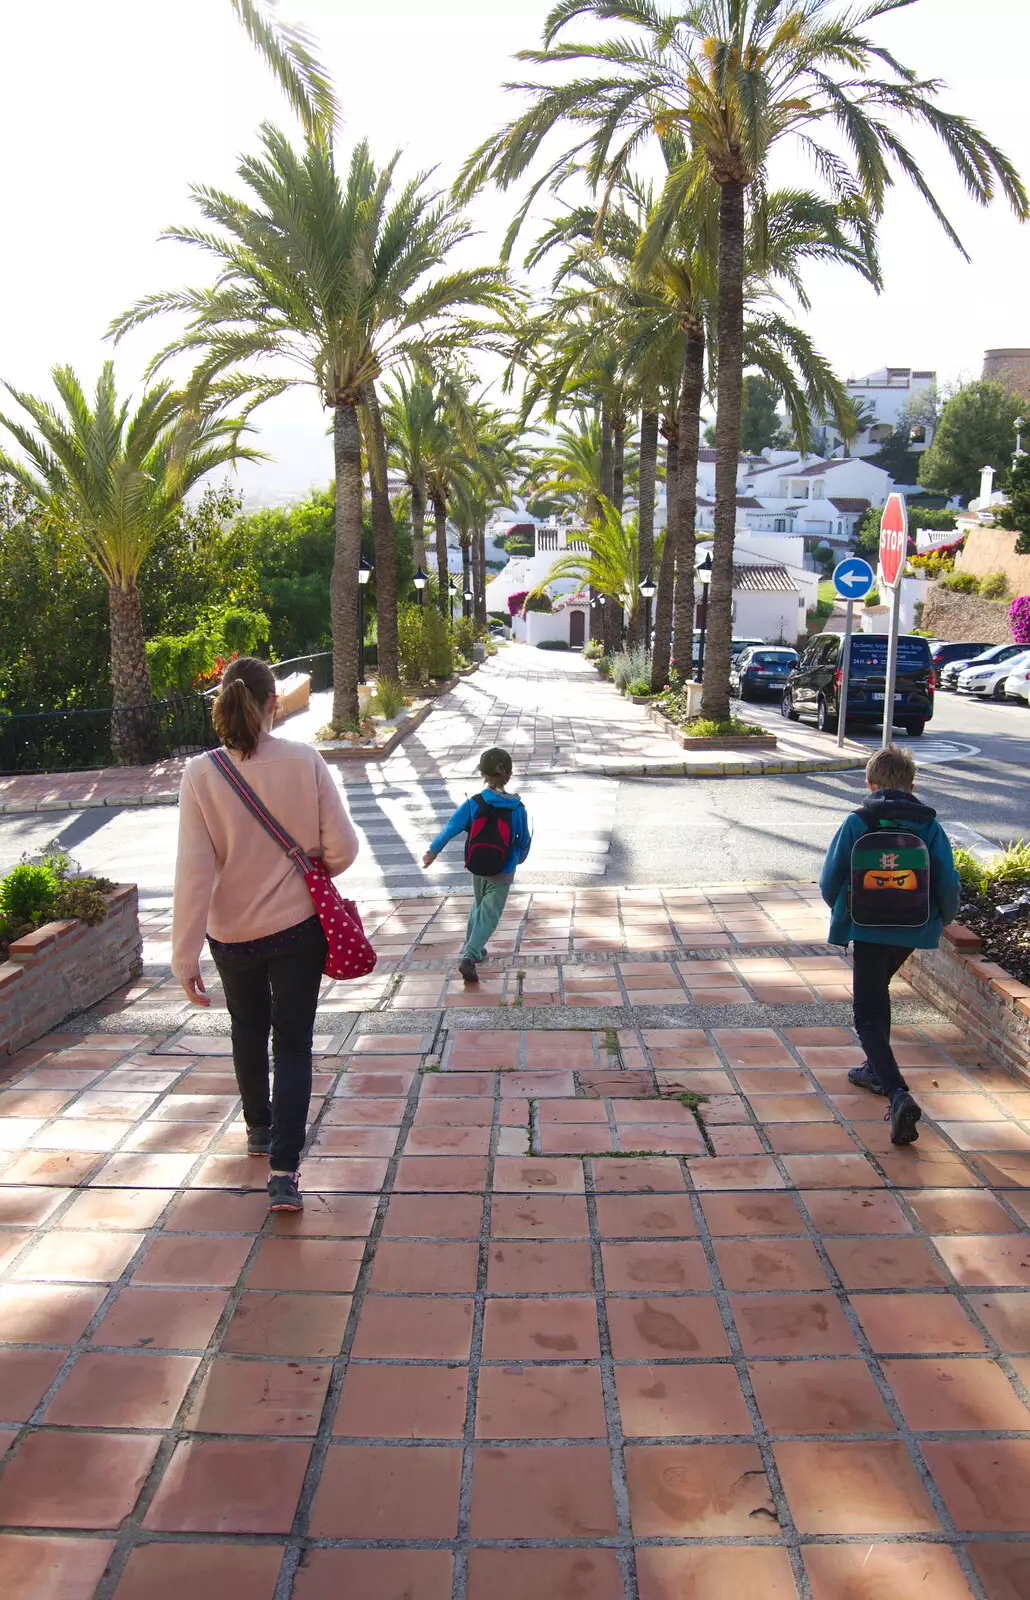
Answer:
0, 690, 218, 774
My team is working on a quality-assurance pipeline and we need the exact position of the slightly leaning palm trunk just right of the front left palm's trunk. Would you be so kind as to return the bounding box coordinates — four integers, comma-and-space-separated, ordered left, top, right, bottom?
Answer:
329, 400, 361, 733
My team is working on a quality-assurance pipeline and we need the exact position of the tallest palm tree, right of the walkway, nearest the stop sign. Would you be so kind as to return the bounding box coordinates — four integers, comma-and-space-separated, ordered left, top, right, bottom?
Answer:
461, 0, 1030, 720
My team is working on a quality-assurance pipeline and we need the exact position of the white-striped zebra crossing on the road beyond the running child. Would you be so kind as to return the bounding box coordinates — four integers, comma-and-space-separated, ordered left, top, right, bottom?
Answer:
345, 776, 619, 891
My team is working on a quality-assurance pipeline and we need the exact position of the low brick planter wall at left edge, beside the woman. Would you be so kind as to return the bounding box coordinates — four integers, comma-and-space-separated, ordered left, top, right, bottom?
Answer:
0, 883, 142, 1058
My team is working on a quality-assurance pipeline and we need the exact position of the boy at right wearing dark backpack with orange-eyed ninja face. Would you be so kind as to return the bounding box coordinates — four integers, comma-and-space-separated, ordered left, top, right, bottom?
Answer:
819, 744, 961, 1144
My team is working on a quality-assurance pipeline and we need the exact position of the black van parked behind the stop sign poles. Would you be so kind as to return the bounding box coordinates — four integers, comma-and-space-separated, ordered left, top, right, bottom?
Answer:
780, 634, 937, 739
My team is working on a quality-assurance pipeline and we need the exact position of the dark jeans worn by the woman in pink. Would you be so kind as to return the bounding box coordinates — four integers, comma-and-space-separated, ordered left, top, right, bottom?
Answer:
207, 918, 326, 1173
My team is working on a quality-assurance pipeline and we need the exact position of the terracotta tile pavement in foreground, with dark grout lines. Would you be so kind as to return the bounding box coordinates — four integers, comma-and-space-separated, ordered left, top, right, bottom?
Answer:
0, 890, 1030, 1600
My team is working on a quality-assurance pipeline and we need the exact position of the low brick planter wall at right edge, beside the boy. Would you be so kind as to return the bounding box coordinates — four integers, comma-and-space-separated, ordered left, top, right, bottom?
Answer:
902, 922, 1030, 1082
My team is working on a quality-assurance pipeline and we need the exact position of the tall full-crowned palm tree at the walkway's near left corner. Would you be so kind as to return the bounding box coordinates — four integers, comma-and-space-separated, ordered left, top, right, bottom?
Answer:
112, 134, 504, 728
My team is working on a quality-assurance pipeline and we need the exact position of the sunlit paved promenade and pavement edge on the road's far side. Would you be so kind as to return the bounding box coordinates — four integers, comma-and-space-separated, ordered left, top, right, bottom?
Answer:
0, 645, 868, 816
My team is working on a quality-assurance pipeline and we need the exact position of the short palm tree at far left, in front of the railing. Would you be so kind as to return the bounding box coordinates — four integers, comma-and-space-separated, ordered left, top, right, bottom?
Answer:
0, 362, 255, 763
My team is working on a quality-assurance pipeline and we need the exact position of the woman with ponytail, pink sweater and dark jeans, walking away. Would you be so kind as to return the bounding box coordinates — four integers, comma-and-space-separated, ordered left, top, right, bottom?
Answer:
171, 656, 358, 1211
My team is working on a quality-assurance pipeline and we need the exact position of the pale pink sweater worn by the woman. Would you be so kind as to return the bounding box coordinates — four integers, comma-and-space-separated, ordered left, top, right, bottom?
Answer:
171, 734, 358, 979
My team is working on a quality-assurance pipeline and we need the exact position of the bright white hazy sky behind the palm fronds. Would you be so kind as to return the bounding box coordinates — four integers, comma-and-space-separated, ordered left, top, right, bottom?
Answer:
0, 0, 1030, 501
